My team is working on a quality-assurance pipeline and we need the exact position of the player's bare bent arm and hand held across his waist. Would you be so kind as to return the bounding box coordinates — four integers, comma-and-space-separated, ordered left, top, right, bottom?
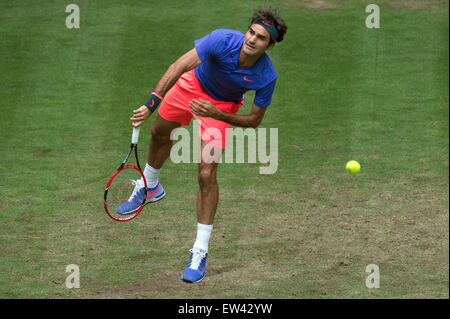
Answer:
189, 99, 267, 128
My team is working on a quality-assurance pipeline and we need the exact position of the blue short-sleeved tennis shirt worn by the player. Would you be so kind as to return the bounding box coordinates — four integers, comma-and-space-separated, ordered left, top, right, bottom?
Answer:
195, 29, 277, 107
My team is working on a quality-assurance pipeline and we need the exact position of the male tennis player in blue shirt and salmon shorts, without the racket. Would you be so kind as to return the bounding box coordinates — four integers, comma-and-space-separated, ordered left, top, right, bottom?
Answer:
127, 8, 287, 282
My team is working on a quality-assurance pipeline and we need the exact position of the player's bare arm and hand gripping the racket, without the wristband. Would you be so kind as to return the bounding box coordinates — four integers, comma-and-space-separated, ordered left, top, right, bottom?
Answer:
130, 48, 202, 127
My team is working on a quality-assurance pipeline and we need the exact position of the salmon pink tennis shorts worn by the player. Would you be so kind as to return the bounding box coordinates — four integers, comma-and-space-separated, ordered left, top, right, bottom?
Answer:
158, 70, 244, 149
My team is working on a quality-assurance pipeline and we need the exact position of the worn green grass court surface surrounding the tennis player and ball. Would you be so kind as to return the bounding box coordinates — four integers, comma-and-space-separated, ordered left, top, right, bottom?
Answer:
0, 0, 449, 299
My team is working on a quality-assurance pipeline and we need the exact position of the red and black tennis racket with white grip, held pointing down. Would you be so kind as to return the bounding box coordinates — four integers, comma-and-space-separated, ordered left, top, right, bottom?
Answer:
104, 127, 147, 221
